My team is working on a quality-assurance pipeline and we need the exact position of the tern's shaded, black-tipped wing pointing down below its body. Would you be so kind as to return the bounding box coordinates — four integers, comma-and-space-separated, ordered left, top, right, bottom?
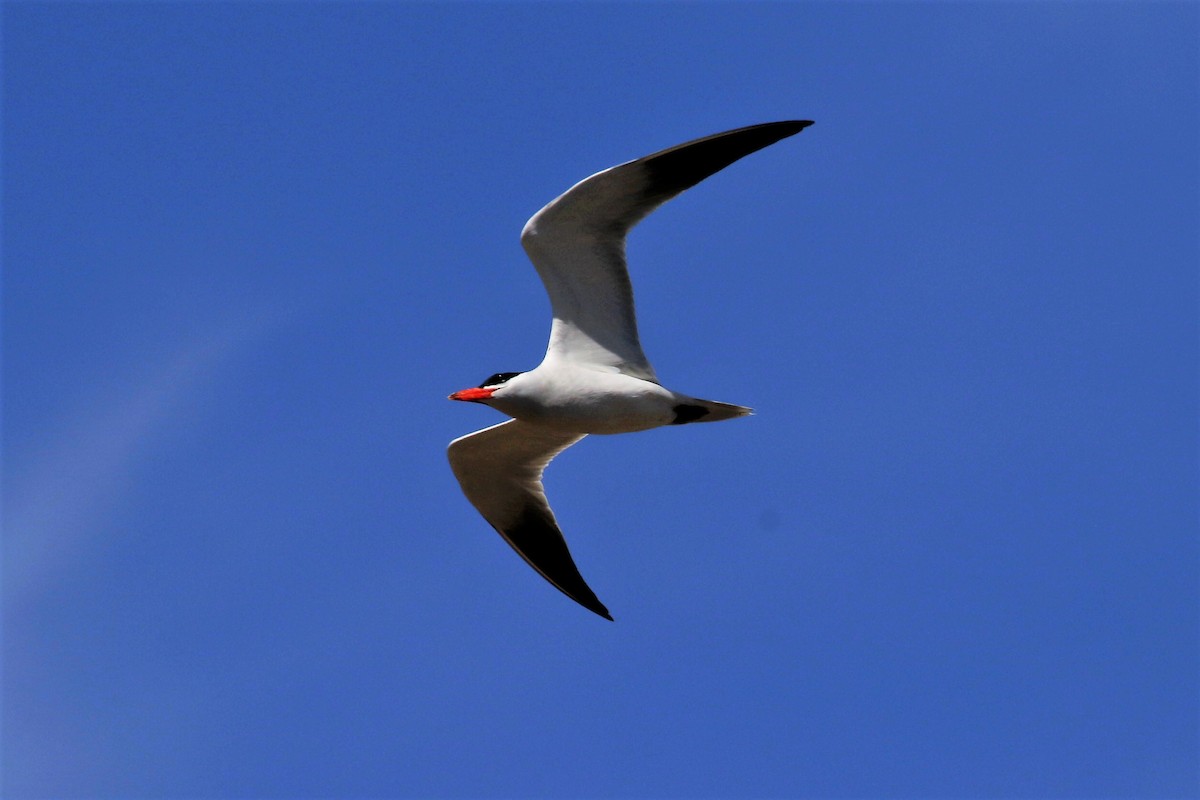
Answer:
449, 420, 612, 619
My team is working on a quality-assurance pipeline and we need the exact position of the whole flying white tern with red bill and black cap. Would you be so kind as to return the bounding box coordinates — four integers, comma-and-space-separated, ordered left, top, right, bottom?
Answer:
449, 120, 812, 620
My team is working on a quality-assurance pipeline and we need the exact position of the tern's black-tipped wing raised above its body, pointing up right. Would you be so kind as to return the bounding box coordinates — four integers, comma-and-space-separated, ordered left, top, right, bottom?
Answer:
521, 121, 812, 380
